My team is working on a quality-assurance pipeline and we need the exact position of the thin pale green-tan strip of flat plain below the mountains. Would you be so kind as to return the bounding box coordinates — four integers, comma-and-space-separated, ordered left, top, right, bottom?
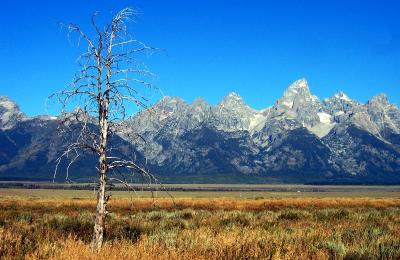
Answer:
0, 182, 400, 199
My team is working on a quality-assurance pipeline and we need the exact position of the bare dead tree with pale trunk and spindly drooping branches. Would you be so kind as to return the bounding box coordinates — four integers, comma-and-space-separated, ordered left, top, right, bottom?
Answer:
53, 8, 159, 250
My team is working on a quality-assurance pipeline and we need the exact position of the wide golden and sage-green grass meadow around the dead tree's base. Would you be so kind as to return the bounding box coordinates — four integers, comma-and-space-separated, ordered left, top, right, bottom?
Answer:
0, 189, 400, 259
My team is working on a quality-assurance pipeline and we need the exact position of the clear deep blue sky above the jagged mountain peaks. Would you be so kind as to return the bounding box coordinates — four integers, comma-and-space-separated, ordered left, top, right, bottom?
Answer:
0, 0, 400, 115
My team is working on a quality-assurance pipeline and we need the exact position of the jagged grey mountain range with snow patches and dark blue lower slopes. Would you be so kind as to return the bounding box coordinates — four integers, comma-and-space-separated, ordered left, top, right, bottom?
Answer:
0, 79, 400, 184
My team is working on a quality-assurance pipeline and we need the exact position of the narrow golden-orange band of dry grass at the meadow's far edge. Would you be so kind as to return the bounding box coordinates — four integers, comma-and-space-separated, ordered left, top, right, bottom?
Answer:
1, 198, 400, 211
